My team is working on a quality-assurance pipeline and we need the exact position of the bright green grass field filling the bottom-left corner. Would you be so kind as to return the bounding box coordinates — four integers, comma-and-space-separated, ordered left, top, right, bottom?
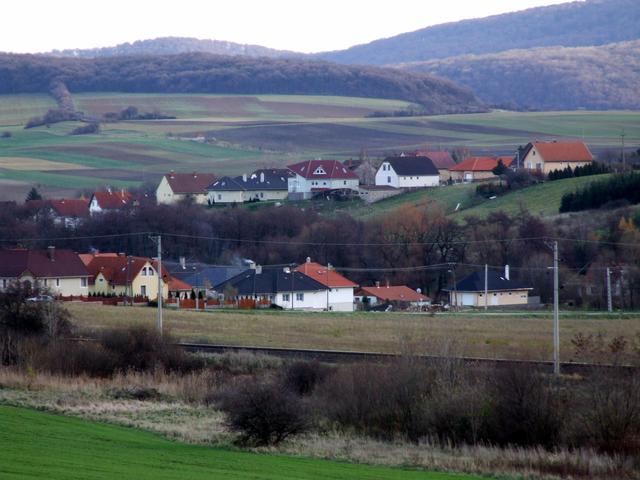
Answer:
0, 407, 480, 480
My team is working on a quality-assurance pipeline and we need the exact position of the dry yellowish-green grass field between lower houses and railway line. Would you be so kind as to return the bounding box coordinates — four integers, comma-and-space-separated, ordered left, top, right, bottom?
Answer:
68, 303, 640, 361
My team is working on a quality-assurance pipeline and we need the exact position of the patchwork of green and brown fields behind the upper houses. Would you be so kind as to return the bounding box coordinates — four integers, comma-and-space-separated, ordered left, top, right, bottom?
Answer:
0, 93, 640, 202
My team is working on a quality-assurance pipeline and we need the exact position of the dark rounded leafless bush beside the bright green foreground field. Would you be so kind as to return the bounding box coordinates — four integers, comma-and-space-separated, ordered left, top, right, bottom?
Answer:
221, 379, 310, 445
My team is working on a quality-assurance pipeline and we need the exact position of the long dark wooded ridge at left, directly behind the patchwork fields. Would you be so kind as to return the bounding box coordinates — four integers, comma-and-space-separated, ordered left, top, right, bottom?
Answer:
0, 53, 485, 114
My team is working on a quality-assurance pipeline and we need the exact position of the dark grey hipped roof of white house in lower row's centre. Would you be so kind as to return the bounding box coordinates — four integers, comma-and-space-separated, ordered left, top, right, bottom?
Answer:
214, 267, 327, 295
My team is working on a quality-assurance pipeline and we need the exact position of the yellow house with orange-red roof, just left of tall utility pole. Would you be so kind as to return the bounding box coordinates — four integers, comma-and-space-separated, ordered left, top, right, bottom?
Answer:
80, 253, 170, 300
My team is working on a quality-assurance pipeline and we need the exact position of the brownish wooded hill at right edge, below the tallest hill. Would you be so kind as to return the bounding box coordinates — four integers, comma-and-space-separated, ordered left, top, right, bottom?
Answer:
402, 40, 640, 110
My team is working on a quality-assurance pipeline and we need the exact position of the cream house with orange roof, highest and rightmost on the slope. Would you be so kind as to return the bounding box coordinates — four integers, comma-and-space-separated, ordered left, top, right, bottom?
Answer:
520, 141, 593, 174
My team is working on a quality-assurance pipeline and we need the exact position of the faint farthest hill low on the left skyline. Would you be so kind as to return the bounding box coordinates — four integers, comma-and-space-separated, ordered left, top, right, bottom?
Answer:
45, 37, 302, 58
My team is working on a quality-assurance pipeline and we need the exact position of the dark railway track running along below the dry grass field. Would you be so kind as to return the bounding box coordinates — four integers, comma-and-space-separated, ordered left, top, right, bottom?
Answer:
177, 343, 639, 375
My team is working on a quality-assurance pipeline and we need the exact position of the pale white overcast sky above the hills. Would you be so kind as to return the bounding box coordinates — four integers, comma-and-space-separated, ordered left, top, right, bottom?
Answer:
0, 0, 566, 53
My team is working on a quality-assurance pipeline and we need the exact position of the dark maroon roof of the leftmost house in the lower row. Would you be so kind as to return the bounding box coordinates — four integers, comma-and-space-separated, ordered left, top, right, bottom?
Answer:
0, 249, 89, 278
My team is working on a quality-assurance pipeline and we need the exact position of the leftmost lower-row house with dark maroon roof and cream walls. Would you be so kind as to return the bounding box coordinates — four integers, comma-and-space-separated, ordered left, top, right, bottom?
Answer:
0, 247, 89, 296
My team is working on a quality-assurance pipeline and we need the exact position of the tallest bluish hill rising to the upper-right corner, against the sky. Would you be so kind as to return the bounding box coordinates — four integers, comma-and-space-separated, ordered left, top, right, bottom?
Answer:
317, 0, 640, 65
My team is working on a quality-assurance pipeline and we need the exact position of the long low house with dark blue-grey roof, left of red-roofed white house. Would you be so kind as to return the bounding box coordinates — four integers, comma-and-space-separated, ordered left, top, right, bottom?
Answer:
207, 168, 293, 205
